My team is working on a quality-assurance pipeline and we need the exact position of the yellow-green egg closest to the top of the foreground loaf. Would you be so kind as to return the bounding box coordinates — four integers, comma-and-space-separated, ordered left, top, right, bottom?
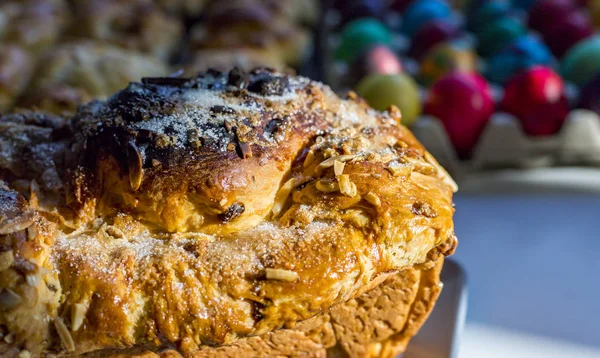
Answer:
356, 73, 421, 126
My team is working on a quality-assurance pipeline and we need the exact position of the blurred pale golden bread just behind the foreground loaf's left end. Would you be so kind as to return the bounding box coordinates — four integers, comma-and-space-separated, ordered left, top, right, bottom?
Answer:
17, 41, 170, 114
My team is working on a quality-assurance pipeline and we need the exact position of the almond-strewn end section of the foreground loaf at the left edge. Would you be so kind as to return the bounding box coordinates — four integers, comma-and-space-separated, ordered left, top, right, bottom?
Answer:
0, 181, 61, 357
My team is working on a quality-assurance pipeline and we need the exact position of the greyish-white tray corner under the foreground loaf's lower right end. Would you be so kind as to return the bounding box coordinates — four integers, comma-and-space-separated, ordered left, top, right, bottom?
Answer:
398, 259, 467, 358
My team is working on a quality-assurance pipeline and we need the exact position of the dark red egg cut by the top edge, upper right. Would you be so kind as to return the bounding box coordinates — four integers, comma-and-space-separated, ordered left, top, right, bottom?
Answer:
528, 0, 577, 33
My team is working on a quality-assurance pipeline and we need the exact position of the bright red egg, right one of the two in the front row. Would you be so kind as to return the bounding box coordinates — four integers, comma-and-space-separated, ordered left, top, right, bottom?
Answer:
501, 66, 569, 136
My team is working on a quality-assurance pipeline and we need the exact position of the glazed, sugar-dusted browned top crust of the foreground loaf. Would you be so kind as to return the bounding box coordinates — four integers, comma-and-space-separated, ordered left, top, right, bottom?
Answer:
0, 70, 455, 353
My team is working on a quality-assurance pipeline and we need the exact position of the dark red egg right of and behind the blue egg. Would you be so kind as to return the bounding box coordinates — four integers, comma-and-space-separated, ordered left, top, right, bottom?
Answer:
544, 10, 594, 57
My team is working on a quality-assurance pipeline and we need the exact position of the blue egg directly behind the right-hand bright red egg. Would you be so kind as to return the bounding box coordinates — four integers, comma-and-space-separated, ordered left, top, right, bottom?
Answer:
485, 36, 554, 84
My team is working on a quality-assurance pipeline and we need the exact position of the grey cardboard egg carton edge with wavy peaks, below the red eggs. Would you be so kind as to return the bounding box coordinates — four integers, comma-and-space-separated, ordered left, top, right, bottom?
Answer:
411, 109, 600, 182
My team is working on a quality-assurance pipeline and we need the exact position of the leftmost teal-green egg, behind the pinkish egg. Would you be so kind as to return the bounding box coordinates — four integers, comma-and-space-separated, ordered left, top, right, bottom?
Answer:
335, 18, 392, 62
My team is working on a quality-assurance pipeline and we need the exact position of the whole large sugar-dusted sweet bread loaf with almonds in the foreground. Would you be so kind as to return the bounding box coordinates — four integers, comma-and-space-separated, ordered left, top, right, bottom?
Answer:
0, 69, 456, 357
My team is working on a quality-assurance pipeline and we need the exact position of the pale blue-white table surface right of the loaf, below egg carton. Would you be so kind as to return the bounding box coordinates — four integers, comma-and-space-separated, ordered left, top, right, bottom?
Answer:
454, 194, 600, 352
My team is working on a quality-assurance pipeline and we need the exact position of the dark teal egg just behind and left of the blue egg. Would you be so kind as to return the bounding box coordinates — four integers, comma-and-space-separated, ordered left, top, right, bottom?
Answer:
477, 17, 527, 57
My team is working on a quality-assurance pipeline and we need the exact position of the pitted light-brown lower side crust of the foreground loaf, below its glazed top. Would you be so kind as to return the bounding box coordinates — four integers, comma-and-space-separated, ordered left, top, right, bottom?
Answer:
75, 258, 443, 358
